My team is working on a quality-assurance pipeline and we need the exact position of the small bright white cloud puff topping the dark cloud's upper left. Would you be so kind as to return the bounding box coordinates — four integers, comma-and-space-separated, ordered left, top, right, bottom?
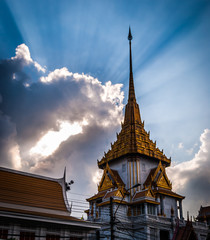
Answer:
11, 43, 46, 72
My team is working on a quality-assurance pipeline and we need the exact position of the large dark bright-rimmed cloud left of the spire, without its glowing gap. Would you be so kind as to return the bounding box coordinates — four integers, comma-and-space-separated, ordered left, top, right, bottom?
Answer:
0, 44, 123, 175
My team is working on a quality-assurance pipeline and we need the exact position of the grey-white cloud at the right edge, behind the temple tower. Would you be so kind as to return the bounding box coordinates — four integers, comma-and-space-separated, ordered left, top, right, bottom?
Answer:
167, 129, 210, 218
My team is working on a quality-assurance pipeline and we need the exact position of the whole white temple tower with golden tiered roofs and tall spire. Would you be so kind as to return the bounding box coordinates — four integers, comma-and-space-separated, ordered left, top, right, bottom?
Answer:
86, 28, 208, 240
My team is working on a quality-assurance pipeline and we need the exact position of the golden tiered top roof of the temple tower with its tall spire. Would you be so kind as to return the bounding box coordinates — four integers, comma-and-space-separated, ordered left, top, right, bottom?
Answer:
98, 28, 171, 169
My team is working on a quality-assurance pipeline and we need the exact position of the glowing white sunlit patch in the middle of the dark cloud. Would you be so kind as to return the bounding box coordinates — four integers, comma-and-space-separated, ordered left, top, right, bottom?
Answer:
29, 120, 88, 157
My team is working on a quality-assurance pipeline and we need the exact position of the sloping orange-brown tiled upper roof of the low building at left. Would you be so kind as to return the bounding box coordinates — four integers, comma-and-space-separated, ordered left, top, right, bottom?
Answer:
0, 168, 70, 215
